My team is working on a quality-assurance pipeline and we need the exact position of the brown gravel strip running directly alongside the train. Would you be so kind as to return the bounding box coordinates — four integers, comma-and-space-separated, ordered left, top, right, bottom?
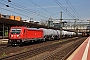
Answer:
0, 38, 76, 56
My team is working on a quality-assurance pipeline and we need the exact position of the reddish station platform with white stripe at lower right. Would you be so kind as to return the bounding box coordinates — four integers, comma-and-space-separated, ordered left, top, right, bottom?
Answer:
66, 37, 90, 60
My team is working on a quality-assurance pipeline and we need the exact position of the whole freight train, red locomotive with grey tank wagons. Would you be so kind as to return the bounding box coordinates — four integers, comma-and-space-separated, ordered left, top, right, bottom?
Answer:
8, 26, 82, 45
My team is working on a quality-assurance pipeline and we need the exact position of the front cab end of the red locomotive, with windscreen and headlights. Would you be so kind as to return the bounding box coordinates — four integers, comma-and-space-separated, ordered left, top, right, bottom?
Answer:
8, 27, 24, 45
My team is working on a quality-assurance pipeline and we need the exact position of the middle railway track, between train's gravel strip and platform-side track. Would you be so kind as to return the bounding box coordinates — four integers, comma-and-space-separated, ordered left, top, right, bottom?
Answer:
1, 38, 86, 60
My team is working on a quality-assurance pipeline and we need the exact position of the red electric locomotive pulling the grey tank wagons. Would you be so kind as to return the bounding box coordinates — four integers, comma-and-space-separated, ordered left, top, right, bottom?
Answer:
8, 26, 44, 45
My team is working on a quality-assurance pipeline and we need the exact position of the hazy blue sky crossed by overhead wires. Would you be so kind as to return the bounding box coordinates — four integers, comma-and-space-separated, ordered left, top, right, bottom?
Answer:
0, 0, 90, 21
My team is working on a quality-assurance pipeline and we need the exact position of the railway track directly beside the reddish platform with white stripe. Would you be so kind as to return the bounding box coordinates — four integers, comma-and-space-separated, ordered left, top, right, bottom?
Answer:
42, 38, 86, 60
